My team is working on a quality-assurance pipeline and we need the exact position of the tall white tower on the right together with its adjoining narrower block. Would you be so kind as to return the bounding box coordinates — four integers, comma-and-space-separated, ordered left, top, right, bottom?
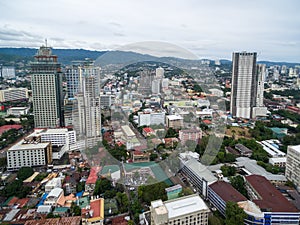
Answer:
230, 52, 266, 119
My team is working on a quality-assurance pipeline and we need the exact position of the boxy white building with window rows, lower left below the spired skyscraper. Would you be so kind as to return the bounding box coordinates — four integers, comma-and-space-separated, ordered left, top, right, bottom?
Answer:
6, 138, 52, 171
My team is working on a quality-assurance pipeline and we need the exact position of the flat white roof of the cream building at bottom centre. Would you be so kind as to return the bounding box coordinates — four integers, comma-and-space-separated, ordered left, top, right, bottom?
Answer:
164, 195, 209, 219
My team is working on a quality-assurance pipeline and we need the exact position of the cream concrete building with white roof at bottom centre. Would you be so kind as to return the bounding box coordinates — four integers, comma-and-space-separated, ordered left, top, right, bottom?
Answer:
150, 194, 210, 225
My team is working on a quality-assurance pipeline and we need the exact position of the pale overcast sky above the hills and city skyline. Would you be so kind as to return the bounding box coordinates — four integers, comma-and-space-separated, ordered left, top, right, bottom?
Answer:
0, 0, 300, 62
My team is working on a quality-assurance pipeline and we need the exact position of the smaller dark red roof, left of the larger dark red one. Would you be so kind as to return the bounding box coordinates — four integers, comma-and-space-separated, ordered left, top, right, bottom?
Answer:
209, 181, 247, 202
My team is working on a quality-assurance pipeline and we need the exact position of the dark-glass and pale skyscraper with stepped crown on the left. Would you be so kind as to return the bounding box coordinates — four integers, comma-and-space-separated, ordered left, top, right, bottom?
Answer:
31, 46, 64, 128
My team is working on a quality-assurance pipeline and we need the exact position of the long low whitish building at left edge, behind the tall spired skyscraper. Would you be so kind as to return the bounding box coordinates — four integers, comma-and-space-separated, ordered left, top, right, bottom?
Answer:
0, 88, 29, 102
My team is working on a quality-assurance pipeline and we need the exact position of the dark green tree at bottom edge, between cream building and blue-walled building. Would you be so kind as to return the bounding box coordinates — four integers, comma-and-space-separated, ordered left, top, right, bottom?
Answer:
225, 201, 247, 225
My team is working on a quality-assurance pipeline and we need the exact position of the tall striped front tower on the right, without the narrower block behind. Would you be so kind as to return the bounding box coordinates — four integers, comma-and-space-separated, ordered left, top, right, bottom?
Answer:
230, 52, 257, 119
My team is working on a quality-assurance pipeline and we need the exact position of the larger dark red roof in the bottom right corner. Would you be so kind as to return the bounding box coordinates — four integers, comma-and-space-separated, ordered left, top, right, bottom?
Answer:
246, 175, 299, 212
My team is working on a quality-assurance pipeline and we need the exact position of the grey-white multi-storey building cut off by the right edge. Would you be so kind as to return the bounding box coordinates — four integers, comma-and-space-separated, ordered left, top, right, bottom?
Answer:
285, 145, 300, 191
